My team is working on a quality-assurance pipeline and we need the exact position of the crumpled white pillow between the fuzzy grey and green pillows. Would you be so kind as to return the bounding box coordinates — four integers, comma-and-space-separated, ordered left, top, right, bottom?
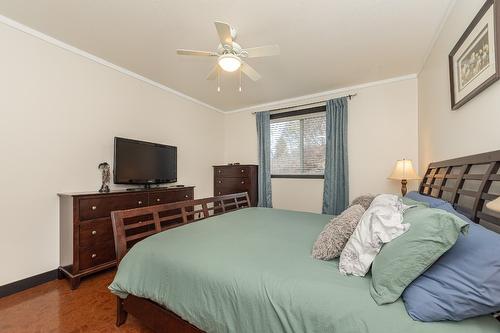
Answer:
339, 194, 410, 276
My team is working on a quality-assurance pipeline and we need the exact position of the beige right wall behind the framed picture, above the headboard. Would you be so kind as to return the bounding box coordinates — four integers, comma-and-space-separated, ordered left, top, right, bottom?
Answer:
418, 0, 500, 170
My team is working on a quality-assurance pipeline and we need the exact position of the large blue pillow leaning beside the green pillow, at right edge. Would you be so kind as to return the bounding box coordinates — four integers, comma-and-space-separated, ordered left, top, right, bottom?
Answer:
403, 215, 500, 321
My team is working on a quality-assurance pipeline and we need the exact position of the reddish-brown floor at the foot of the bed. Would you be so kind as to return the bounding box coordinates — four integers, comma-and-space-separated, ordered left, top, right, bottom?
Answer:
0, 271, 151, 333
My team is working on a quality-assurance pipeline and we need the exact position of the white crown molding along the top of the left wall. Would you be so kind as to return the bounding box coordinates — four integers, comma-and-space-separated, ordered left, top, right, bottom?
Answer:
0, 15, 224, 113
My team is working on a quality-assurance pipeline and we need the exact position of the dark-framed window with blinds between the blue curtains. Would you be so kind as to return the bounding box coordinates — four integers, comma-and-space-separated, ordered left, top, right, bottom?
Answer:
271, 106, 326, 178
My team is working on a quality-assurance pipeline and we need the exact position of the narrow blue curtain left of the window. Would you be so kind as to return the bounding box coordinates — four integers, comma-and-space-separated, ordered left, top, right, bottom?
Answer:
256, 112, 273, 208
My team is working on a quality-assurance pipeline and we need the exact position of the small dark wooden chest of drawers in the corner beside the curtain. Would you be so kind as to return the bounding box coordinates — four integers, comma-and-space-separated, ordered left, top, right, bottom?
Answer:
214, 164, 258, 207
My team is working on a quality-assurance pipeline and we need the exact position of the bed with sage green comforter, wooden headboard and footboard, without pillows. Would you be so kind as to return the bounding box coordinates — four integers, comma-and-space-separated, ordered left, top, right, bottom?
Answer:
110, 151, 500, 333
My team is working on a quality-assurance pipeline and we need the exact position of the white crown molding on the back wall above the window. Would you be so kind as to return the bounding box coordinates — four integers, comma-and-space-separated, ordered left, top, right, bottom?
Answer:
224, 74, 417, 114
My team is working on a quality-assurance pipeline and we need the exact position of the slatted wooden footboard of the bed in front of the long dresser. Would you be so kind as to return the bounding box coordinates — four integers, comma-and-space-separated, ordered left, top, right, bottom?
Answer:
111, 192, 250, 263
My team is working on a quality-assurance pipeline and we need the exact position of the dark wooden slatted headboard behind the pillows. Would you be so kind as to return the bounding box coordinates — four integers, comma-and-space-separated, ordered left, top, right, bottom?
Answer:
419, 150, 500, 232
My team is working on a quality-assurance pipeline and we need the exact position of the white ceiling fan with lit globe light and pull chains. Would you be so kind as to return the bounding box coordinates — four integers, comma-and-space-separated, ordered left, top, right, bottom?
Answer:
177, 21, 280, 91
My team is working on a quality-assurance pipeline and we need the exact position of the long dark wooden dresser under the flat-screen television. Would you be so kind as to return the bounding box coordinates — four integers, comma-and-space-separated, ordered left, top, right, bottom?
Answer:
59, 186, 194, 289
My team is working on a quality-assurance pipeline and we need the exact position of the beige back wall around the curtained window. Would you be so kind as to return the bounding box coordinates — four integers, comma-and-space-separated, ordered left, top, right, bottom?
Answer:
225, 79, 418, 212
